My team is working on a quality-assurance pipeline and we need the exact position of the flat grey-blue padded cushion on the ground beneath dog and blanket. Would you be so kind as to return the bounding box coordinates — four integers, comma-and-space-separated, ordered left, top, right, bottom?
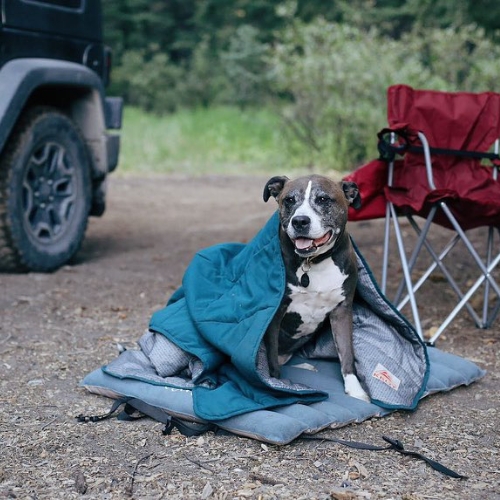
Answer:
81, 348, 485, 444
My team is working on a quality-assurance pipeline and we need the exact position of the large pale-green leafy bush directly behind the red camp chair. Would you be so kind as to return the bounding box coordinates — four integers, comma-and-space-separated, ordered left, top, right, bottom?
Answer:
268, 19, 500, 170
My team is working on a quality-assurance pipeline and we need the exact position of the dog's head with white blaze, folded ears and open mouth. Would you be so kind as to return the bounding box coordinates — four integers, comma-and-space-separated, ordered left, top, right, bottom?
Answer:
264, 175, 361, 257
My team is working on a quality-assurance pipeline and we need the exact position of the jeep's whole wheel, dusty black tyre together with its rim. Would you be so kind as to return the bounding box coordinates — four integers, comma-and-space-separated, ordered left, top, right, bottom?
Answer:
0, 107, 91, 272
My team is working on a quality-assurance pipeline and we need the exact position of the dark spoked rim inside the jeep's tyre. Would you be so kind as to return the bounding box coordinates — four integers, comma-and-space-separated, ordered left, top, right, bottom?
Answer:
22, 142, 77, 244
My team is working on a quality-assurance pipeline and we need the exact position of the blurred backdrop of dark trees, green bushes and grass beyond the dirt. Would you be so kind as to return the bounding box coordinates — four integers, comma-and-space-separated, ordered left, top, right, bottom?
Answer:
102, 0, 500, 172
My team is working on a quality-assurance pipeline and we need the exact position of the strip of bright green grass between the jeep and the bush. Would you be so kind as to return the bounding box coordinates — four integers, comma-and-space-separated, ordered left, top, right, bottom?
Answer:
117, 107, 296, 175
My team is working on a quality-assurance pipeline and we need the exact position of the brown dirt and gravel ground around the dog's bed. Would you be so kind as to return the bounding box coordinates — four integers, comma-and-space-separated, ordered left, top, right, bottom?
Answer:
0, 176, 500, 500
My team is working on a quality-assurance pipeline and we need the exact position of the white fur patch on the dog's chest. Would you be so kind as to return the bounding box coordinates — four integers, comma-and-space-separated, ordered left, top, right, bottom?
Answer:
287, 258, 347, 338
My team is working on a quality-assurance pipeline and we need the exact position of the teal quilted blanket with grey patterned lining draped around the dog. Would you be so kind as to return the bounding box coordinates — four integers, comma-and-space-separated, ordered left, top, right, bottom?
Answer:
102, 213, 429, 421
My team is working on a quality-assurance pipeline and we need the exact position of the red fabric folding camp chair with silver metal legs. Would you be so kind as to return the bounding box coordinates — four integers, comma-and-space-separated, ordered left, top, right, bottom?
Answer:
347, 85, 500, 344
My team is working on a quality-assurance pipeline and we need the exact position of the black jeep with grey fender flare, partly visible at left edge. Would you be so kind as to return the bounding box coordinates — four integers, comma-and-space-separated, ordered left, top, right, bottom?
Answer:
0, 0, 122, 272
